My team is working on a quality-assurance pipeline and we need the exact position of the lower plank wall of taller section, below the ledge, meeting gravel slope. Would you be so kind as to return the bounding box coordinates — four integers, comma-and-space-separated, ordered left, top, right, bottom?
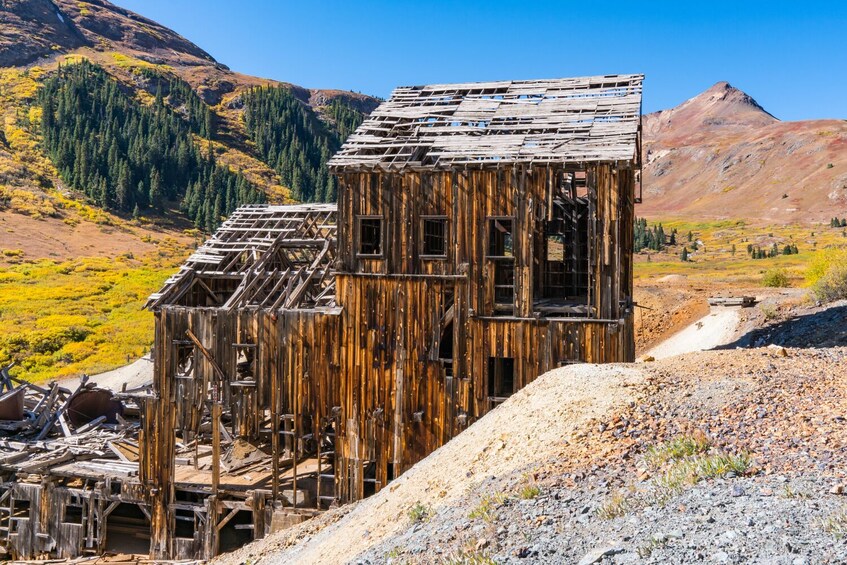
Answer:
337, 275, 635, 500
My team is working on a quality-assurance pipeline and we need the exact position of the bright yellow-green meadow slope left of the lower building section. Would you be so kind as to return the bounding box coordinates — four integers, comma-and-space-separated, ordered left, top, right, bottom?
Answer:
0, 239, 186, 381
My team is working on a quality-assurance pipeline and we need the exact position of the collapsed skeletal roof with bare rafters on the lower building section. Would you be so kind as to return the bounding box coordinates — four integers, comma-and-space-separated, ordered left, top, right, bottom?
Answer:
145, 204, 338, 310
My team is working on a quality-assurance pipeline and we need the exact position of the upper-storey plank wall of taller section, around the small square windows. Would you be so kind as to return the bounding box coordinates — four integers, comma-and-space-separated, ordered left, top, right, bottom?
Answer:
338, 163, 635, 319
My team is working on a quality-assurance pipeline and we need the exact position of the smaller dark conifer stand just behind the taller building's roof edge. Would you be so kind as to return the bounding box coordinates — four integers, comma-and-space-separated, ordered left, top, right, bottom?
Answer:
244, 87, 364, 202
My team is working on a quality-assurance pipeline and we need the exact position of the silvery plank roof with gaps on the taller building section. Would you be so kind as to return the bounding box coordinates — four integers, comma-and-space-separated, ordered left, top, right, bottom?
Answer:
329, 75, 644, 173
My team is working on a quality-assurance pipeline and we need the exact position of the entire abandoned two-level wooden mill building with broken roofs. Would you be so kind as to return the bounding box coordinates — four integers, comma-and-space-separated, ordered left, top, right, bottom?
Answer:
0, 75, 643, 559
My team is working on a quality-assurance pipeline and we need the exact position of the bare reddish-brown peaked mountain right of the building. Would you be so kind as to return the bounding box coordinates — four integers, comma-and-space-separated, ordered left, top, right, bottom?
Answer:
636, 82, 847, 223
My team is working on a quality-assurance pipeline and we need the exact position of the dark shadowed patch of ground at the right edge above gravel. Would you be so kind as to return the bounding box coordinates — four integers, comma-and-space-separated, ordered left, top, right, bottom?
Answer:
715, 301, 847, 349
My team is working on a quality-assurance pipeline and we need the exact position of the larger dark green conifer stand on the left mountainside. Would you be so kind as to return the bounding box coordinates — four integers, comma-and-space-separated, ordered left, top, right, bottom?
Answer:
38, 61, 264, 231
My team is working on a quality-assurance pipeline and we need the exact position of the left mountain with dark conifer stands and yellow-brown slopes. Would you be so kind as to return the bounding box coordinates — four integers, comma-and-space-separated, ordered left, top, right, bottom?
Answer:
0, 0, 379, 261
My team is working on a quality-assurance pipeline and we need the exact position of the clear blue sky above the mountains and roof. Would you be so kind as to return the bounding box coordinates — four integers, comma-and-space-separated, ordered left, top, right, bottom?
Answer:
113, 0, 847, 120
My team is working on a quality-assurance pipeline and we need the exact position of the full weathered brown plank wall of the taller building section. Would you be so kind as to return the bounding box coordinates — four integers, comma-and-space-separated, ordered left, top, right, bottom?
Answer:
336, 163, 635, 500
